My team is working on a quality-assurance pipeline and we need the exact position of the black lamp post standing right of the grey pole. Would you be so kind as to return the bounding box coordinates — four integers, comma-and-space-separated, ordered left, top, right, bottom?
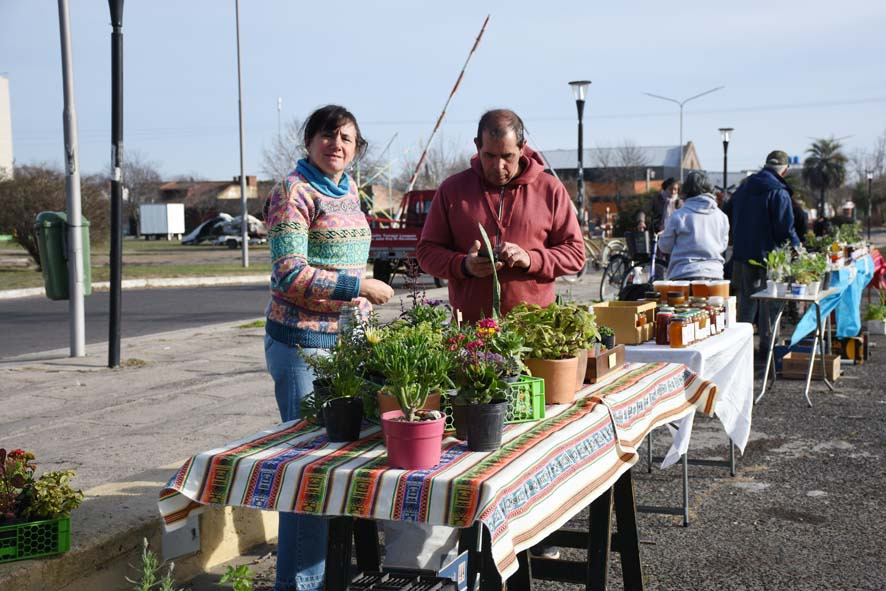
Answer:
108, 0, 123, 368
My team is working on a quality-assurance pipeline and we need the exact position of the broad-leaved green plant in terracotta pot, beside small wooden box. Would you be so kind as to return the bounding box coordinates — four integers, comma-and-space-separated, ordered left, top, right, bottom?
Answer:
503, 302, 596, 404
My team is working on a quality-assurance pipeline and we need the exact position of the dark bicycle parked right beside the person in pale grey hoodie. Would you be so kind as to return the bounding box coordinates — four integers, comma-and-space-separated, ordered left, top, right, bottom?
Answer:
600, 231, 667, 302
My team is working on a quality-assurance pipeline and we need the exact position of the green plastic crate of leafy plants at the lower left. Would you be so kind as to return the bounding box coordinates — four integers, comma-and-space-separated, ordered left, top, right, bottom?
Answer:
0, 448, 83, 563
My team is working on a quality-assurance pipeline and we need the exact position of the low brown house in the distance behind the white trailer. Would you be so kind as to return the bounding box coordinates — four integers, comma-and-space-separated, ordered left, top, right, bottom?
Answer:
159, 175, 262, 232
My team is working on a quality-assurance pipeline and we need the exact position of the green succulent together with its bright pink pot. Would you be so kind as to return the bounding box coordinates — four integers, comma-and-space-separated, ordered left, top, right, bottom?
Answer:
372, 323, 451, 470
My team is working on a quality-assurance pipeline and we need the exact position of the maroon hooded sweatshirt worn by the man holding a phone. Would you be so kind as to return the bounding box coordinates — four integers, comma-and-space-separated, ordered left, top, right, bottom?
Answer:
417, 146, 585, 322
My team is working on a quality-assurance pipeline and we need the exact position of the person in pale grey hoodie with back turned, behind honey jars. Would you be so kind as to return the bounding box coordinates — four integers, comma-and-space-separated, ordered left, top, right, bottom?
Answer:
658, 171, 729, 280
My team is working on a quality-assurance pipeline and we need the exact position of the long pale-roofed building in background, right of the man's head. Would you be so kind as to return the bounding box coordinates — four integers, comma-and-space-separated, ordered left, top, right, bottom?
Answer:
543, 142, 704, 216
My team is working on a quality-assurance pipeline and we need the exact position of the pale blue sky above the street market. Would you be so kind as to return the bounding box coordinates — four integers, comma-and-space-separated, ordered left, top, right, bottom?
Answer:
0, 0, 886, 179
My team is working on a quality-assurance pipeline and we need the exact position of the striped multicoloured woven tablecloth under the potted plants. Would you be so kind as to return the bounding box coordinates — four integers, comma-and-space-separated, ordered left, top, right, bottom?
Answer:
159, 363, 716, 577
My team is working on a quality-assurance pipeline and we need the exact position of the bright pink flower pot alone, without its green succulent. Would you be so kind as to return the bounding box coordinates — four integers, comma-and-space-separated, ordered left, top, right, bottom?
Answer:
381, 410, 446, 470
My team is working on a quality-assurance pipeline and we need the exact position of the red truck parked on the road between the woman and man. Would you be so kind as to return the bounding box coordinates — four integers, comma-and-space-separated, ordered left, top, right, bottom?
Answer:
366, 190, 446, 287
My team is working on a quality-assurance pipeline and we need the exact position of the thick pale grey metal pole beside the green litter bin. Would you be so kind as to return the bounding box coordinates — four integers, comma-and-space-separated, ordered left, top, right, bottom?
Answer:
58, 0, 88, 357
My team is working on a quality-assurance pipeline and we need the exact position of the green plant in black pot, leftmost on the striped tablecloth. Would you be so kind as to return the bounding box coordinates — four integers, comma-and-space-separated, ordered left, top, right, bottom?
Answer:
302, 324, 369, 442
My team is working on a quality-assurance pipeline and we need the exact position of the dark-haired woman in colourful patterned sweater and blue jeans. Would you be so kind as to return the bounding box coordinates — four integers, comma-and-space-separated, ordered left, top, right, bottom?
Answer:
265, 105, 394, 591
